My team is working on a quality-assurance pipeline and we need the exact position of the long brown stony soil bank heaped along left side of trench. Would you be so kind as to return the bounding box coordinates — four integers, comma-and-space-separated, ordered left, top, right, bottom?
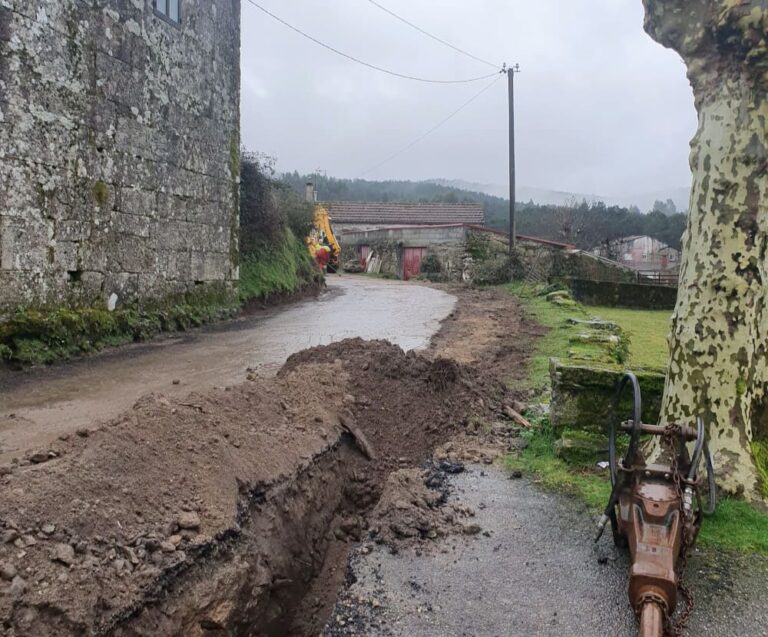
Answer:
0, 365, 345, 635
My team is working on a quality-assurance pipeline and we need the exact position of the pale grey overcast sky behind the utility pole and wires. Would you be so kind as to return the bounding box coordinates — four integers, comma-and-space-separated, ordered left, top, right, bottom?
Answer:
242, 0, 696, 196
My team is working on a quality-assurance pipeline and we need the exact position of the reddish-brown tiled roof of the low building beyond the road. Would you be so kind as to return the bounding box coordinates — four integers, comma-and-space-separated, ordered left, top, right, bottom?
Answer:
320, 201, 485, 225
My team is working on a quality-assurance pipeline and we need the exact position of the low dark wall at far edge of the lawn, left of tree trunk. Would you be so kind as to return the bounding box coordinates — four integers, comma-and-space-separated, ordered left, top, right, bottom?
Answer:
568, 278, 677, 310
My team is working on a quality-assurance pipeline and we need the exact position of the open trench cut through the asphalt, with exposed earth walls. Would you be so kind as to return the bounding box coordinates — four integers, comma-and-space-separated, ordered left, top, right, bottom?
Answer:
116, 434, 380, 637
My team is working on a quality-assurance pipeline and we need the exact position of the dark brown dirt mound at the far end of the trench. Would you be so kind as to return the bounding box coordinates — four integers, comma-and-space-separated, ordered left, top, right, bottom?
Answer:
279, 339, 510, 473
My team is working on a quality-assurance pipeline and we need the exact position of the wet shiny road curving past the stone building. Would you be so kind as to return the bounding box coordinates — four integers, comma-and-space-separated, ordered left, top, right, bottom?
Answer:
0, 276, 456, 460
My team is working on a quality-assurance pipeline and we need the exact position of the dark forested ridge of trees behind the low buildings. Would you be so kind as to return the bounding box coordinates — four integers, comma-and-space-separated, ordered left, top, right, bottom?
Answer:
280, 171, 686, 250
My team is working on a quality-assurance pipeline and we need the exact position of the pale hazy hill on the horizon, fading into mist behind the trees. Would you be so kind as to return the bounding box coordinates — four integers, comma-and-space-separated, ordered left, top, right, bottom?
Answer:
427, 179, 690, 212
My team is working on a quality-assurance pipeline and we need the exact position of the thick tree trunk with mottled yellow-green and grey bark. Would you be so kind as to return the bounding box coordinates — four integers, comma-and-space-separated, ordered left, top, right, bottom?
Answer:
644, 0, 768, 500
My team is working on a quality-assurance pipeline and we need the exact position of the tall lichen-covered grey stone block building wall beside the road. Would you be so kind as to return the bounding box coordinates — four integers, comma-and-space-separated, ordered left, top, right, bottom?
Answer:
0, 0, 240, 313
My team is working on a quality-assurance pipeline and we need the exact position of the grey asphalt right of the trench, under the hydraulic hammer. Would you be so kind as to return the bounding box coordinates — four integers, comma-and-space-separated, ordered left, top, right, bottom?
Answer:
326, 467, 768, 637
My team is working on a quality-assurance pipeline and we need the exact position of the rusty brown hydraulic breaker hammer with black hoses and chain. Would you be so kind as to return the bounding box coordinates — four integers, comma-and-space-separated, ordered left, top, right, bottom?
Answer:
595, 373, 715, 637
